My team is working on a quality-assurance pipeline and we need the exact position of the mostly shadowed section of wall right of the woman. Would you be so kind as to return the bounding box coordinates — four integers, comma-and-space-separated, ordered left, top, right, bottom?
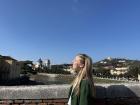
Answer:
94, 84, 140, 105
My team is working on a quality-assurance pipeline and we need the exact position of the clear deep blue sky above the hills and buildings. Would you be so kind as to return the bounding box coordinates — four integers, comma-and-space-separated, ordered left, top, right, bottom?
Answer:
0, 0, 140, 64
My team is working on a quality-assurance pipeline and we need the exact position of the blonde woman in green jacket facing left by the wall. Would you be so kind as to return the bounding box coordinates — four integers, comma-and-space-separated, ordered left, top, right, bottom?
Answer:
68, 54, 95, 105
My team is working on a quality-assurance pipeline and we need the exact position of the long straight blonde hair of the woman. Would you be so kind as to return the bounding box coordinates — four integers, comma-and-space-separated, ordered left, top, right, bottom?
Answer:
72, 54, 95, 96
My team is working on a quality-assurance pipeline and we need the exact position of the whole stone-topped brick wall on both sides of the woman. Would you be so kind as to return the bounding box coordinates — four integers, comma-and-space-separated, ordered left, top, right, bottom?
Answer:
0, 83, 140, 105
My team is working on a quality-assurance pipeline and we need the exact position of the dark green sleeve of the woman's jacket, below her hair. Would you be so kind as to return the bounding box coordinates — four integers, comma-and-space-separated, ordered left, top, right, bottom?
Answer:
79, 81, 90, 105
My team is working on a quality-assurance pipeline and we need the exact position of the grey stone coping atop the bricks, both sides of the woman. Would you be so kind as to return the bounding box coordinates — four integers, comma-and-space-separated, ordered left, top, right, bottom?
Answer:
0, 83, 140, 99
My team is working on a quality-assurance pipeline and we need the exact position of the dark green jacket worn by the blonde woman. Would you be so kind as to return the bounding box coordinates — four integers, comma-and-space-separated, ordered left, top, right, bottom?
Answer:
69, 80, 94, 105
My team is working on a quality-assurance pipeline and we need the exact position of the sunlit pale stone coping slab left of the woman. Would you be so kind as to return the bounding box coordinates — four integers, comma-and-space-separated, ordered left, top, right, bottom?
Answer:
0, 85, 70, 99
